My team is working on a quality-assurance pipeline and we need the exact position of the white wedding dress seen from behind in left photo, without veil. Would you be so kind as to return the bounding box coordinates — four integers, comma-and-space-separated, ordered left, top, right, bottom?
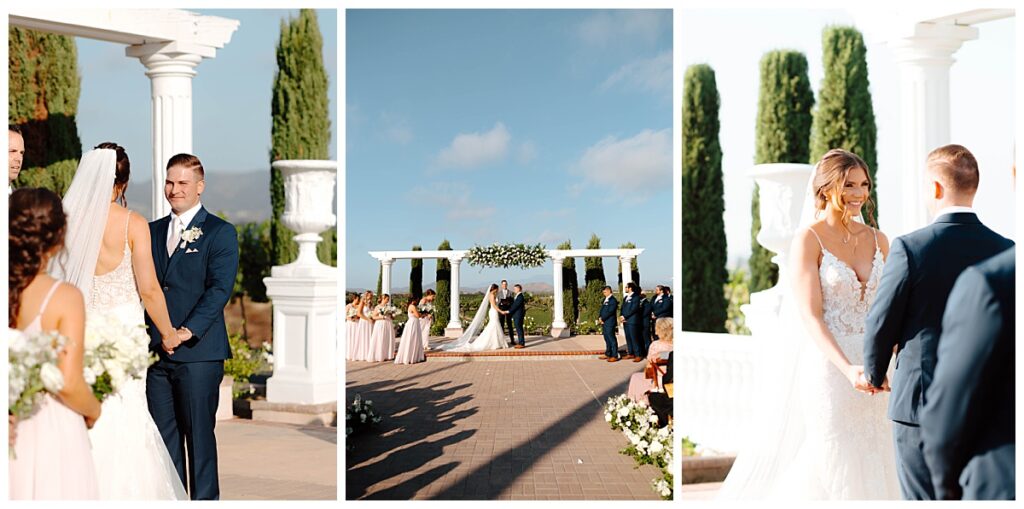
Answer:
86, 221, 188, 500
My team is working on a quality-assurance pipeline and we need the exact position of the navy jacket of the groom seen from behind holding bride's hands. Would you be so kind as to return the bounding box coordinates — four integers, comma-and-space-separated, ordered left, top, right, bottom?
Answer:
864, 213, 1013, 424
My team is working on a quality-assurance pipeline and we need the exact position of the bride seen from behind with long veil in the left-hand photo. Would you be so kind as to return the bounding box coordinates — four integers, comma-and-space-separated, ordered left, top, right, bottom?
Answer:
50, 143, 188, 500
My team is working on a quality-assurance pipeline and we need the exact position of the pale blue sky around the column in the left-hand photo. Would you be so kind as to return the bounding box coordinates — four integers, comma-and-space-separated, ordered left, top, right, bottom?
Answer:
76, 9, 338, 174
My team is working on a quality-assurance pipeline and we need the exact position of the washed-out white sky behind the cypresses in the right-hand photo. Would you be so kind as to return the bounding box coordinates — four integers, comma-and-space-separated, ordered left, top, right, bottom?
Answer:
679, 8, 1015, 266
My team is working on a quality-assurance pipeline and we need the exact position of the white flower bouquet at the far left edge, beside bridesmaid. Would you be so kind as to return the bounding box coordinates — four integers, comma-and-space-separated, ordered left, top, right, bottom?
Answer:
7, 329, 67, 420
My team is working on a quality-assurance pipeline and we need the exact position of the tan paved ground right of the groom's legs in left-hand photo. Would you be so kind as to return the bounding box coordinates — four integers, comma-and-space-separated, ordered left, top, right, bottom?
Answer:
217, 419, 338, 500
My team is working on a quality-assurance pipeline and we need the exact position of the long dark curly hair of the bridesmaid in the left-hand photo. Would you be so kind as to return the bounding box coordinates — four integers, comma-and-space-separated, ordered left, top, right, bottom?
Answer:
7, 187, 68, 328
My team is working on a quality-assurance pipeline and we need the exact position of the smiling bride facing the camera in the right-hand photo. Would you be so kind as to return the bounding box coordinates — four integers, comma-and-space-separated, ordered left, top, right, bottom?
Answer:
719, 150, 899, 500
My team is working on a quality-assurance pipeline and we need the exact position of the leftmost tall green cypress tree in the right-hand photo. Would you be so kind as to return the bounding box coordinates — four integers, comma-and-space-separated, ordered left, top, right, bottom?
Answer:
679, 65, 729, 332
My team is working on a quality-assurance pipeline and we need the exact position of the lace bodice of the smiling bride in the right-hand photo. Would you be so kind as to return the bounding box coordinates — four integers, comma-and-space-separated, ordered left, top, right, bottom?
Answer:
818, 246, 885, 338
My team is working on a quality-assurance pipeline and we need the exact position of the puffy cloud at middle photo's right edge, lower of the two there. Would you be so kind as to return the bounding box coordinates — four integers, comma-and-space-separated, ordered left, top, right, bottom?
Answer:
570, 129, 672, 202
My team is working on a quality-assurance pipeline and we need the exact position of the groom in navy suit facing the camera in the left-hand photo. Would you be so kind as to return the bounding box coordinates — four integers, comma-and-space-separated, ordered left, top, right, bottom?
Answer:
145, 154, 239, 500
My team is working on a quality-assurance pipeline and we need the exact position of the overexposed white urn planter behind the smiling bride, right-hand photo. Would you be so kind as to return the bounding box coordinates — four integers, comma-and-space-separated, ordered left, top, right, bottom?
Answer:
742, 163, 814, 336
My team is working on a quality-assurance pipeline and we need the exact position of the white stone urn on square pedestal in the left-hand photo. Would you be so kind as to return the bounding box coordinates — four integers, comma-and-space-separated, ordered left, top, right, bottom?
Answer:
263, 160, 338, 408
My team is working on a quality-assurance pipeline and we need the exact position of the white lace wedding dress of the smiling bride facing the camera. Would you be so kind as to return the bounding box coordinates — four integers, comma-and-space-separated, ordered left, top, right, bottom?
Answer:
719, 234, 900, 500
